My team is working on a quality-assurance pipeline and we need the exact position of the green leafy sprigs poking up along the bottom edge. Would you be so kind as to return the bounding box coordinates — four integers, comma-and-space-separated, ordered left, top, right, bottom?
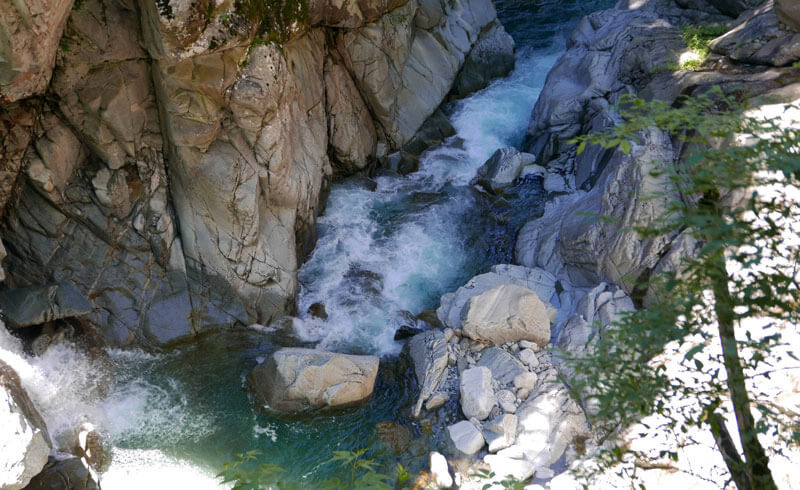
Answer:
217, 449, 411, 490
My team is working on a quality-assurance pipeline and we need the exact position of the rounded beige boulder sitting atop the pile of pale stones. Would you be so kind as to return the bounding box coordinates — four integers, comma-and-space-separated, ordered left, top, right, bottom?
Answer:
461, 284, 550, 346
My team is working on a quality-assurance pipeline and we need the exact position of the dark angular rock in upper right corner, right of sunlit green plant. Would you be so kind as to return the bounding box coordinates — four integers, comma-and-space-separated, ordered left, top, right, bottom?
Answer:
710, 0, 800, 66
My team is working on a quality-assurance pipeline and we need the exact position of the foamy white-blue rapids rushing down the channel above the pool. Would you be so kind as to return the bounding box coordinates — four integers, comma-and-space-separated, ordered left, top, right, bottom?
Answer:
295, 39, 559, 355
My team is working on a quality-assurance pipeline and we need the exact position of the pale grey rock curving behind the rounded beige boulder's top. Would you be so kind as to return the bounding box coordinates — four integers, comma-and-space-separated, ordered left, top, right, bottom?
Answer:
436, 264, 558, 329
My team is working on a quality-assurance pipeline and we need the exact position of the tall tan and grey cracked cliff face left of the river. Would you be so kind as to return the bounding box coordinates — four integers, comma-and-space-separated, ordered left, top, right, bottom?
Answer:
0, 0, 513, 345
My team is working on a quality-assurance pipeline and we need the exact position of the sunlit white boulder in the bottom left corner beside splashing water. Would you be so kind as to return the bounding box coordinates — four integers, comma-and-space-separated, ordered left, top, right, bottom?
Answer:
0, 360, 52, 490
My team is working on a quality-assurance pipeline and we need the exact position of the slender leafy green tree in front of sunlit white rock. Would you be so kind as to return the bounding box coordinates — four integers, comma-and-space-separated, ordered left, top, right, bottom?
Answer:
568, 89, 800, 489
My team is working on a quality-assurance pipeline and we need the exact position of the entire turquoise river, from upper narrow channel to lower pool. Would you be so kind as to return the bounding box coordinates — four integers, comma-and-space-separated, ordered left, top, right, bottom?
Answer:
0, 0, 610, 490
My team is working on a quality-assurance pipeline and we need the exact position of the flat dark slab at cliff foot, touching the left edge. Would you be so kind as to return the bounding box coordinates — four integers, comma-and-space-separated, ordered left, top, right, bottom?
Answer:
0, 282, 92, 328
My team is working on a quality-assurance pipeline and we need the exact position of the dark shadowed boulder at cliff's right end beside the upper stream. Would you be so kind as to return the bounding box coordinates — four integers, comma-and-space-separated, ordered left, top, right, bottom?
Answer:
450, 21, 516, 98
